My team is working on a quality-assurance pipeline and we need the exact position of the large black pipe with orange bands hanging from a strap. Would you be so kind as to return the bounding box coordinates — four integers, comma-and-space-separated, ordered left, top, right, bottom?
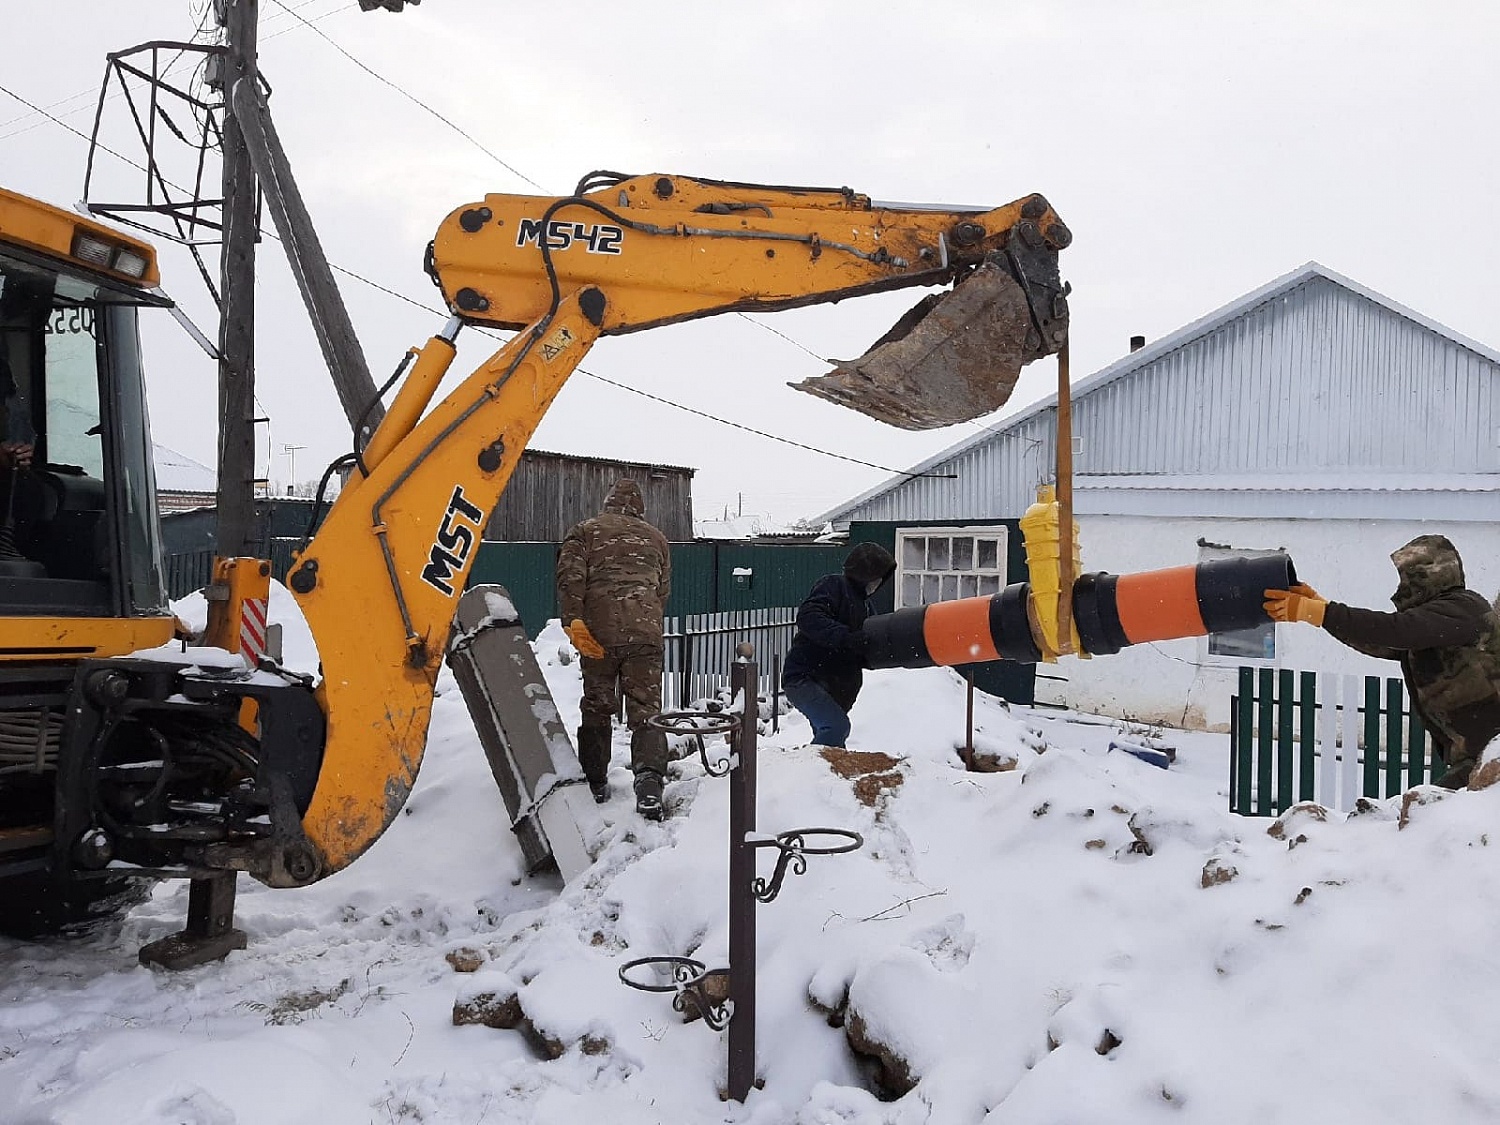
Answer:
864, 552, 1298, 668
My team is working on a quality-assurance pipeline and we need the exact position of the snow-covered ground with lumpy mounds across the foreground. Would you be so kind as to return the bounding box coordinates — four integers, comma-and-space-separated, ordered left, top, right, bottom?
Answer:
0, 606, 1500, 1125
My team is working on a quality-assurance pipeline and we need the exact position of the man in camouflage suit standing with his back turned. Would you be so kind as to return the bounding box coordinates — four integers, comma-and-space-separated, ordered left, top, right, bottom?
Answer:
557, 479, 672, 821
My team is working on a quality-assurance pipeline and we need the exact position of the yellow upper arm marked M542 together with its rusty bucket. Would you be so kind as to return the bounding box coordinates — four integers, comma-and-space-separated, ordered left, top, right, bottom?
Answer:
428, 176, 1073, 429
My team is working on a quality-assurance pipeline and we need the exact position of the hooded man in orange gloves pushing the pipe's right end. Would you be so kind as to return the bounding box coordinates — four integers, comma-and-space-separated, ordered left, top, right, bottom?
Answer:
1266, 536, 1500, 789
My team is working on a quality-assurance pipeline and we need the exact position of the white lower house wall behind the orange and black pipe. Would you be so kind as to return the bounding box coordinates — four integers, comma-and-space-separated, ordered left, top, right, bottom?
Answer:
1037, 516, 1500, 731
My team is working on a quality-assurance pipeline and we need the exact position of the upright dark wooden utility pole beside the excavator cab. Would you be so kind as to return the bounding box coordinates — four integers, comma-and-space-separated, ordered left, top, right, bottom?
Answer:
215, 0, 261, 558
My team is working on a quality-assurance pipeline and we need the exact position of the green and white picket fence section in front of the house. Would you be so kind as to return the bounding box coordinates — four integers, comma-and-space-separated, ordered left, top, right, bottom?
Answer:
1229, 668, 1443, 816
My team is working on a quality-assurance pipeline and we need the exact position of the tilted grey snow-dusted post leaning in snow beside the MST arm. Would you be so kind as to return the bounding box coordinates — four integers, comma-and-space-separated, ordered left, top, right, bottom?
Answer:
449, 585, 603, 881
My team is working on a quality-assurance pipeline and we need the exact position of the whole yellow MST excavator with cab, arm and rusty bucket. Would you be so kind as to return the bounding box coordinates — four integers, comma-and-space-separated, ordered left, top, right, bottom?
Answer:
0, 173, 1071, 954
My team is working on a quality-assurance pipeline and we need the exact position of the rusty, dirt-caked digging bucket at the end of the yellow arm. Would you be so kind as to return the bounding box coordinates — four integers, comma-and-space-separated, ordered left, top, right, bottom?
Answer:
789, 255, 1068, 429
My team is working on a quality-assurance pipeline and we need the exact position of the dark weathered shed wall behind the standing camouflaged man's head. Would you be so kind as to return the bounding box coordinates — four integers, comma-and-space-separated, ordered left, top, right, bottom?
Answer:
485, 450, 693, 543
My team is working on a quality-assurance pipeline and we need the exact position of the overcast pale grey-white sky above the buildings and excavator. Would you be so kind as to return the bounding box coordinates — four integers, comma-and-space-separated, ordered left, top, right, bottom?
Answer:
0, 0, 1500, 519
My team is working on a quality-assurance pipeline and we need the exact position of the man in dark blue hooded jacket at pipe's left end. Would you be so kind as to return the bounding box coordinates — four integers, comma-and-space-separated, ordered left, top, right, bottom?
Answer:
782, 543, 896, 747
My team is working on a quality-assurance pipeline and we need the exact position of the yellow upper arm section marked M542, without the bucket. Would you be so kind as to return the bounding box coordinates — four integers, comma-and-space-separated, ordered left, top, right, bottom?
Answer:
429, 176, 1071, 336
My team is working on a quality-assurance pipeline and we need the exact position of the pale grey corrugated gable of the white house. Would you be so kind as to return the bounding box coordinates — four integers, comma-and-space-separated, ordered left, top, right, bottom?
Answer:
840, 276, 1500, 524
